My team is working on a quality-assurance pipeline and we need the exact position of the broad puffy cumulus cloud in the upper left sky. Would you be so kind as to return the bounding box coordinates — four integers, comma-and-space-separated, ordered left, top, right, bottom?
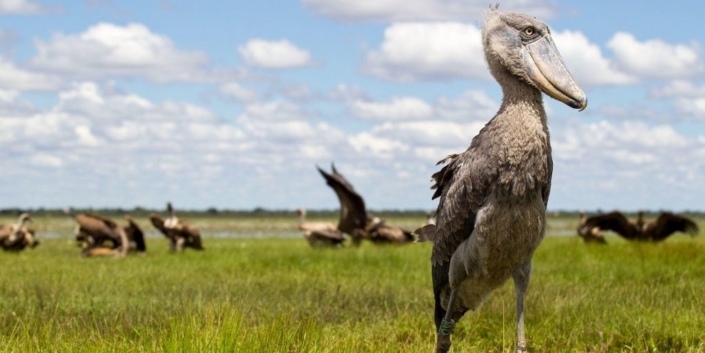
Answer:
30, 23, 238, 83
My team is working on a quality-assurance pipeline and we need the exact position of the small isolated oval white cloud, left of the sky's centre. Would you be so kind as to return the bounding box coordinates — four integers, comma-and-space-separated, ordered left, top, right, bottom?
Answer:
237, 39, 313, 69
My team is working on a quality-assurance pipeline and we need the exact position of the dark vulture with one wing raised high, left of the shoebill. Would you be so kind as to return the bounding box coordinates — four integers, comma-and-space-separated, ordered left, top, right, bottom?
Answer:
318, 165, 414, 246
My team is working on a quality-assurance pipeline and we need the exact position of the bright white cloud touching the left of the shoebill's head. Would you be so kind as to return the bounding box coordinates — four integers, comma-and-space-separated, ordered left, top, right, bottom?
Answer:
364, 22, 490, 81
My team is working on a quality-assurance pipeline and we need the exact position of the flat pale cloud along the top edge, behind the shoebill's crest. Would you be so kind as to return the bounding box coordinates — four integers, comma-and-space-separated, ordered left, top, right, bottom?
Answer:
303, 0, 556, 22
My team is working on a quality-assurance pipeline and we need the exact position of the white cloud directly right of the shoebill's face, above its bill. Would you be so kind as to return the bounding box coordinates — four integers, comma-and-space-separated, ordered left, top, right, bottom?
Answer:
553, 30, 639, 86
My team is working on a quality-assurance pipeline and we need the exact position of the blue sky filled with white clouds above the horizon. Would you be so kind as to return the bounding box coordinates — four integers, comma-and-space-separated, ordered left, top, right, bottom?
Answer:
0, 0, 705, 211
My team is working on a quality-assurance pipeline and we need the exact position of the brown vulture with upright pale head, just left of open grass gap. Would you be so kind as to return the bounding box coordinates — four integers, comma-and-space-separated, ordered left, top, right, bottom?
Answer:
149, 202, 203, 252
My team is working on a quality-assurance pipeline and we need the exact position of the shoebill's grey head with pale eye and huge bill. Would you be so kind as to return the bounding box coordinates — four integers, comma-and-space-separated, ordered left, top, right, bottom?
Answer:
482, 6, 587, 110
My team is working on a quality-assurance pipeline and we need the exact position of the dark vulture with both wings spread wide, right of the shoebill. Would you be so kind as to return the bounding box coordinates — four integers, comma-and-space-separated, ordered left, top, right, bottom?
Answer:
585, 211, 699, 242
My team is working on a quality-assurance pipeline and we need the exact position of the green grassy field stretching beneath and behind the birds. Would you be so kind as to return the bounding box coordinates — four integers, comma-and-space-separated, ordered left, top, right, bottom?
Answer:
0, 216, 705, 352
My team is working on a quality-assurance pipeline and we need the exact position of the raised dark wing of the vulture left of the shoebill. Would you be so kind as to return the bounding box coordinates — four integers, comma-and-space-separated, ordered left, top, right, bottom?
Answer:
318, 164, 367, 235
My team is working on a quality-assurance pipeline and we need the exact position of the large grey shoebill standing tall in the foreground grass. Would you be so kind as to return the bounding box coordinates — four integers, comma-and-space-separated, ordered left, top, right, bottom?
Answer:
417, 6, 587, 352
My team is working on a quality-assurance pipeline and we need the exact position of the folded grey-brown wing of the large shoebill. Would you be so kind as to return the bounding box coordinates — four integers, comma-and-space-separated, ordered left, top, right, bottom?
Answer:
431, 150, 496, 266
